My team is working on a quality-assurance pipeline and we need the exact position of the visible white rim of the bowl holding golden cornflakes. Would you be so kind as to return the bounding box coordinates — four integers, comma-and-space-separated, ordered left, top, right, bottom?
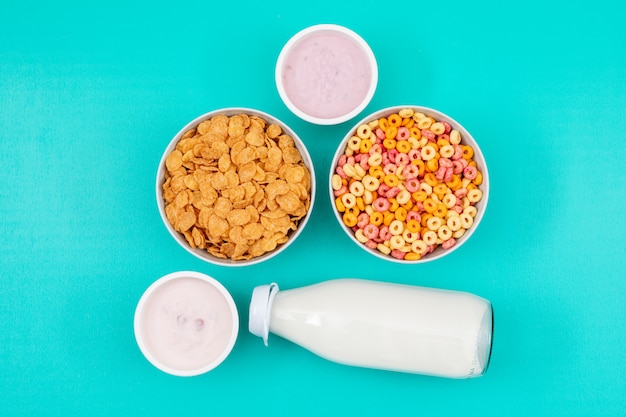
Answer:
156, 107, 316, 266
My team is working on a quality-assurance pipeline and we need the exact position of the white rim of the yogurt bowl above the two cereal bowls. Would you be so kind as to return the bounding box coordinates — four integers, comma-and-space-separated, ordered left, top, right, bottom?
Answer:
274, 23, 378, 125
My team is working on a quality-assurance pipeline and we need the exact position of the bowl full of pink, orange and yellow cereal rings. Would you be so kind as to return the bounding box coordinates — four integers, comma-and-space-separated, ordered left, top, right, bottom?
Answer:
329, 106, 489, 263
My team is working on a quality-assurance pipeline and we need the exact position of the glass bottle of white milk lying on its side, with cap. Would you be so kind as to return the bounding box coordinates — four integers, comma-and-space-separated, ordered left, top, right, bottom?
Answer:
250, 279, 492, 378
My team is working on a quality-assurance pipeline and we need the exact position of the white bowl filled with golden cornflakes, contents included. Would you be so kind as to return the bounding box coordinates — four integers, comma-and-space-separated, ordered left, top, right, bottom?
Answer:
156, 108, 315, 266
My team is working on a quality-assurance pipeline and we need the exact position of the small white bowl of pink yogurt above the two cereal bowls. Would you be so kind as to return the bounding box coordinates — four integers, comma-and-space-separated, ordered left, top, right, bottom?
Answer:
276, 24, 378, 125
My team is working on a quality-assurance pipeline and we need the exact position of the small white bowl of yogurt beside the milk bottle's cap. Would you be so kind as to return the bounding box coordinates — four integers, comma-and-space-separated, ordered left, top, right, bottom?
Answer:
134, 271, 239, 376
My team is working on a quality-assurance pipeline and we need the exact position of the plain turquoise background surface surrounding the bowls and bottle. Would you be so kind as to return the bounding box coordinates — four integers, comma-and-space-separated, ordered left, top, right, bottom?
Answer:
0, 0, 626, 417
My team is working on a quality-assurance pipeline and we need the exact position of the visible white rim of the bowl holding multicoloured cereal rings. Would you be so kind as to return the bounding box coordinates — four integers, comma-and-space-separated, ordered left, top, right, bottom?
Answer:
329, 105, 489, 264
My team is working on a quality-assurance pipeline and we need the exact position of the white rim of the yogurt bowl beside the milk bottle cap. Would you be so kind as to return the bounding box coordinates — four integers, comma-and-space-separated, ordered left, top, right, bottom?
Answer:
133, 271, 239, 376
